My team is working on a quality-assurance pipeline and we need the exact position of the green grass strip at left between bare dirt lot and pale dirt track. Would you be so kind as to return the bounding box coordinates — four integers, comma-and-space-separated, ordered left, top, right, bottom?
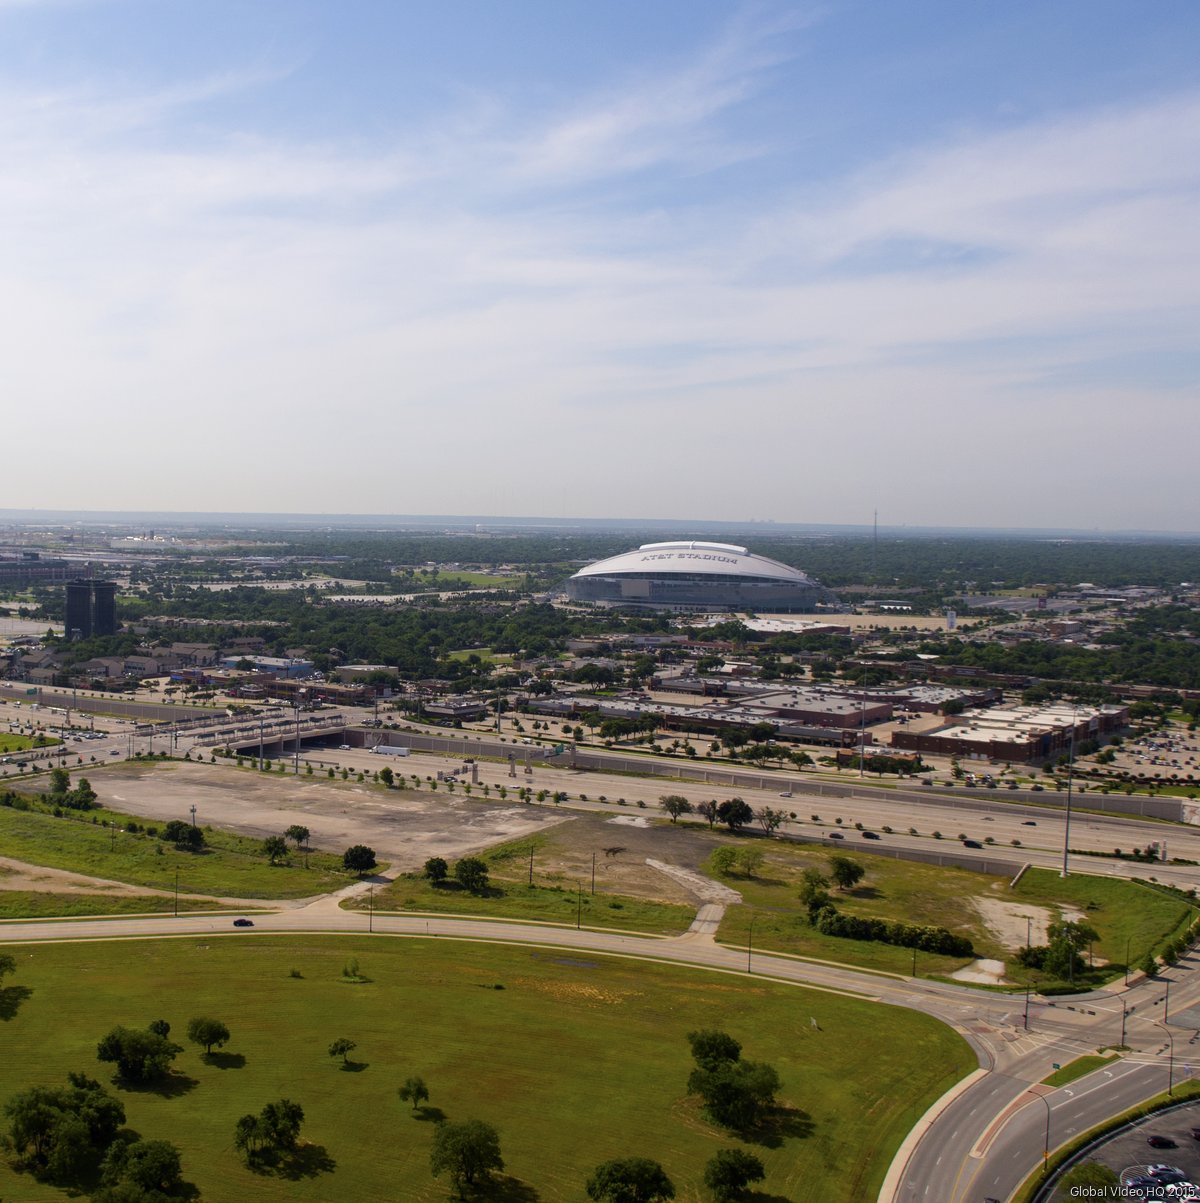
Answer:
0, 802, 367, 899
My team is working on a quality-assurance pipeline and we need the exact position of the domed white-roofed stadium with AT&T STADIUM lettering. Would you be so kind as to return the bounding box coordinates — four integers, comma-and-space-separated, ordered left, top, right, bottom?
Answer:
566, 541, 830, 612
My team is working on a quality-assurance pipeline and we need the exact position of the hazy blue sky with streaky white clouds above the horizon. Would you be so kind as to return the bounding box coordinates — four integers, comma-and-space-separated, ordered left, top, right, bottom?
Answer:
0, 0, 1200, 532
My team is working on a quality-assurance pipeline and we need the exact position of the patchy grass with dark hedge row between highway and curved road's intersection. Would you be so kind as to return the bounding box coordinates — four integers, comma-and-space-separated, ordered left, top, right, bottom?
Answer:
714, 841, 1193, 983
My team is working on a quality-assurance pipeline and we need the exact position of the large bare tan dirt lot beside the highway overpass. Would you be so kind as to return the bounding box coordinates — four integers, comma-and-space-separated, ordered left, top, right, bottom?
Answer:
89, 761, 568, 870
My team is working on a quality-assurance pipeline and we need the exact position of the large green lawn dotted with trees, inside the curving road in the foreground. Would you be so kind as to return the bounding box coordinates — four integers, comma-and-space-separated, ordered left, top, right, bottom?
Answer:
0, 935, 975, 1203
